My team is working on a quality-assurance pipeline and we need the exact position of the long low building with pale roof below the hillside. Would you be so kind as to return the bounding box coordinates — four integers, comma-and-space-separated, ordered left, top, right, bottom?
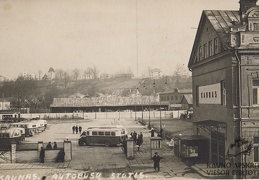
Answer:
50, 95, 168, 113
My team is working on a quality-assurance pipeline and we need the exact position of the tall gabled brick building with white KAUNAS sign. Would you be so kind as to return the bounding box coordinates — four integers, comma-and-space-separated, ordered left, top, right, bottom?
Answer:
188, 0, 259, 177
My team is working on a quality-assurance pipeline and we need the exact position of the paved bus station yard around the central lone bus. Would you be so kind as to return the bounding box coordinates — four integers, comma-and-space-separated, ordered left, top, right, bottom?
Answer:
0, 120, 202, 179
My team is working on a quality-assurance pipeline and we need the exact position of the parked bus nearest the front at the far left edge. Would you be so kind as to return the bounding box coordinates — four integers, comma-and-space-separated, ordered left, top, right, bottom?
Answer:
0, 128, 22, 146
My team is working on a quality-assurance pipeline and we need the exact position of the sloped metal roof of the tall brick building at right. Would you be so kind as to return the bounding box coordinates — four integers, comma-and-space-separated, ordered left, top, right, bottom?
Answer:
188, 10, 240, 67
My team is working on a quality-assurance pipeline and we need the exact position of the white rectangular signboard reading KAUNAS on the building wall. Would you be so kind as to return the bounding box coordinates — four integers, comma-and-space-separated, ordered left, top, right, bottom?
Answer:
199, 83, 221, 104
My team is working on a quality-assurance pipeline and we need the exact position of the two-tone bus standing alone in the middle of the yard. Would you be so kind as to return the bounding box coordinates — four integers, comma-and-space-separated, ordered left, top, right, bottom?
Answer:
78, 126, 127, 147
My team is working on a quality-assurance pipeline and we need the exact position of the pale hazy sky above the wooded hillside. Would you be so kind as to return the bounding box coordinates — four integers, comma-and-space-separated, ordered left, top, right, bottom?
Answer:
0, 0, 243, 79
